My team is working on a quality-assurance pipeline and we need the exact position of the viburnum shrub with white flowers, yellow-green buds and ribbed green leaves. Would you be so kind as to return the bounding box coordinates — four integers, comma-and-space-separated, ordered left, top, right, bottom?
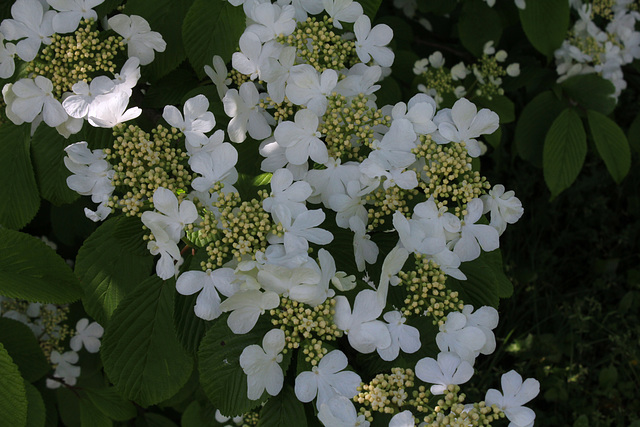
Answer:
21, 0, 640, 427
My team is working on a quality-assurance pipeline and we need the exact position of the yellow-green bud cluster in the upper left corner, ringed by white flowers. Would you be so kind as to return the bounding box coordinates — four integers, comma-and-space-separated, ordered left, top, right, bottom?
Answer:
26, 19, 125, 99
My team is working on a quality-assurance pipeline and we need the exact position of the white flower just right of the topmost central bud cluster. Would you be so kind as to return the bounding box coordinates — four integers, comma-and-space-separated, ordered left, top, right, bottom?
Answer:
353, 15, 395, 67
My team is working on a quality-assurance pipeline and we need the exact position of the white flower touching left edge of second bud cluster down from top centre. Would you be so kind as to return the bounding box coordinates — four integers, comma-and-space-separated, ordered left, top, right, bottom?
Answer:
274, 110, 329, 165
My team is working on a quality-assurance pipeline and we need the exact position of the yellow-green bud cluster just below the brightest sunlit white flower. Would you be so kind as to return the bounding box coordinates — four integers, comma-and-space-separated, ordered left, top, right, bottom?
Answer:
104, 124, 194, 216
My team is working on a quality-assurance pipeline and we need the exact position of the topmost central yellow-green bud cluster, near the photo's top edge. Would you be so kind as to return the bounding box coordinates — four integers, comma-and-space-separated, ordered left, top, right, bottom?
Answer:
276, 16, 359, 73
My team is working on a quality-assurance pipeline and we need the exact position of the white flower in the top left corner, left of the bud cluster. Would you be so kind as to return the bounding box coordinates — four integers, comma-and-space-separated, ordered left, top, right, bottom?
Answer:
0, 0, 56, 62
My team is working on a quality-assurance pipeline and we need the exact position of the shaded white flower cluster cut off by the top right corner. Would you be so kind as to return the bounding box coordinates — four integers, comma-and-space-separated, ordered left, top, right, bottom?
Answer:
555, 0, 640, 98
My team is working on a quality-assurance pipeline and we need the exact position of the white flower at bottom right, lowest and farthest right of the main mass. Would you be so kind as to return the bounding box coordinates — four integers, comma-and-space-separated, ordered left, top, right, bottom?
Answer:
484, 370, 540, 427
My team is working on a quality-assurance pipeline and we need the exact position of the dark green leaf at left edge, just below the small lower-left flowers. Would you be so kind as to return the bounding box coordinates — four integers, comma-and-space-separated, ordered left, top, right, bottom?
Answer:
0, 317, 51, 382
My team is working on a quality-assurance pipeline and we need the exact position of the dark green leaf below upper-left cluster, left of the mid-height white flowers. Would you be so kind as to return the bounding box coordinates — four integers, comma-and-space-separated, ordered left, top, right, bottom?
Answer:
31, 125, 80, 205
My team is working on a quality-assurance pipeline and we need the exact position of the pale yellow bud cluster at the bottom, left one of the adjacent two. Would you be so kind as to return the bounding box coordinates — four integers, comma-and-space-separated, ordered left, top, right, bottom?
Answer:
353, 368, 415, 422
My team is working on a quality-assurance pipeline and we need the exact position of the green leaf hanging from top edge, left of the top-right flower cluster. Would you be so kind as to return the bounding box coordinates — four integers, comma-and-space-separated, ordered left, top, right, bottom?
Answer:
520, 0, 569, 57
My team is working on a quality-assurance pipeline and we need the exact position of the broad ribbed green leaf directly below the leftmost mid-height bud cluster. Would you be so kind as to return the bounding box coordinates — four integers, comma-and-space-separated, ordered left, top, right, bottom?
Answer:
76, 217, 153, 326
